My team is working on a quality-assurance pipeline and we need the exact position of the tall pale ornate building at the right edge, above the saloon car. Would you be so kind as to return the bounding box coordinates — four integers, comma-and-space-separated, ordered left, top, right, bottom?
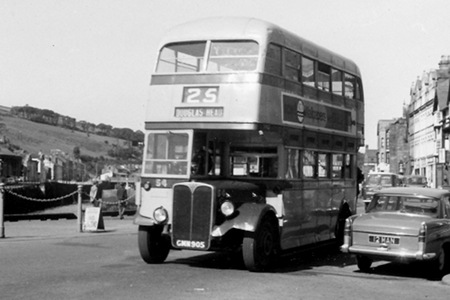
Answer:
408, 56, 450, 187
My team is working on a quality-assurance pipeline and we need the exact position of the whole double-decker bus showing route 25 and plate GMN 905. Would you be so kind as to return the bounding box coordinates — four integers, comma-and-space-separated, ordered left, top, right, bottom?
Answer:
135, 17, 364, 271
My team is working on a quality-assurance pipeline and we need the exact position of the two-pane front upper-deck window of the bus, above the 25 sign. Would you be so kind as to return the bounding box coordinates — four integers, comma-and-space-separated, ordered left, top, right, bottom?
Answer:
156, 41, 259, 73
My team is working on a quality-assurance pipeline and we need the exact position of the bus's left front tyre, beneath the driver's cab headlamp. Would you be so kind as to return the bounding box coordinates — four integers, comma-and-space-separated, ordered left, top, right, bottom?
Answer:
138, 226, 170, 264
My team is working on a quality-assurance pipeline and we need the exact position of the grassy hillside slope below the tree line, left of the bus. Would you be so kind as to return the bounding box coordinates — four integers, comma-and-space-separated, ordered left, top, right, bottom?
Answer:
0, 113, 131, 158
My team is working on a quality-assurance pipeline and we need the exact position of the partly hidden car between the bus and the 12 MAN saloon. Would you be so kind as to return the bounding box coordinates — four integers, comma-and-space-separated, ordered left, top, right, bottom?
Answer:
361, 172, 402, 209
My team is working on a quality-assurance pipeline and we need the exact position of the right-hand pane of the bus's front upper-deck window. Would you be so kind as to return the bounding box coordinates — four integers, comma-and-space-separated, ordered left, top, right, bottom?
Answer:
206, 41, 258, 72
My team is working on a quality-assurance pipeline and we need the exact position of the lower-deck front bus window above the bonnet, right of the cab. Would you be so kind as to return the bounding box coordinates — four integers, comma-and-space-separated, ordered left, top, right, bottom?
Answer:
230, 147, 278, 178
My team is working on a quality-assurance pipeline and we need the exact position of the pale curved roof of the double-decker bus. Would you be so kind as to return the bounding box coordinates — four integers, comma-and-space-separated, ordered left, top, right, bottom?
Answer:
160, 17, 360, 76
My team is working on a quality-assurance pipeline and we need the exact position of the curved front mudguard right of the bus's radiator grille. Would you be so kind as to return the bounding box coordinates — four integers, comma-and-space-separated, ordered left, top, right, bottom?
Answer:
211, 203, 276, 237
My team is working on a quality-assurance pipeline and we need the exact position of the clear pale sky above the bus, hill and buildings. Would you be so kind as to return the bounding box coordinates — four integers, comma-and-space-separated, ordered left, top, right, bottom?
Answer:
0, 0, 450, 149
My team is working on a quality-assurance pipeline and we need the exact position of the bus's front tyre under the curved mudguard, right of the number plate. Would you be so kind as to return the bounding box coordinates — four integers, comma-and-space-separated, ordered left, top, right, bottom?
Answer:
242, 216, 278, 272
